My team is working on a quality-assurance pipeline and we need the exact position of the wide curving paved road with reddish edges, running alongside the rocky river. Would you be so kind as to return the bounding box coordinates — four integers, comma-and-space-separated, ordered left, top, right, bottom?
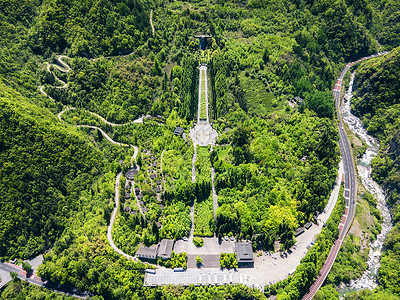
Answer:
303, 52, 388, 300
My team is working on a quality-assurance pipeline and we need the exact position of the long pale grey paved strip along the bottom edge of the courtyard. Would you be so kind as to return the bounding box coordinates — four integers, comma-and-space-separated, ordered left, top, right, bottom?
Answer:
144, 269, 242, 286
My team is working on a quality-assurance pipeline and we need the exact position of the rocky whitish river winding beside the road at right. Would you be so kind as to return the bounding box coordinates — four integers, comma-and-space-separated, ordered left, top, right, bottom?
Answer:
341, 73, 393, 290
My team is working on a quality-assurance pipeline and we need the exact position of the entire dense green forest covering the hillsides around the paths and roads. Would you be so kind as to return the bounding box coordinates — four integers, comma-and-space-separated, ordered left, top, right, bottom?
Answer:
0, 0, 400, 299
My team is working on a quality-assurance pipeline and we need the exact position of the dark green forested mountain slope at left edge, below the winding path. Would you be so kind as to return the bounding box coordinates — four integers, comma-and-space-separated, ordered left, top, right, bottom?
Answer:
0, 82, 102, 258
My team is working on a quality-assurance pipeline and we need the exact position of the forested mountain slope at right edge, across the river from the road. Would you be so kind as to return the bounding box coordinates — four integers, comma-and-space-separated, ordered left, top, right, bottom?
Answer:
352, 48, 400, 295
